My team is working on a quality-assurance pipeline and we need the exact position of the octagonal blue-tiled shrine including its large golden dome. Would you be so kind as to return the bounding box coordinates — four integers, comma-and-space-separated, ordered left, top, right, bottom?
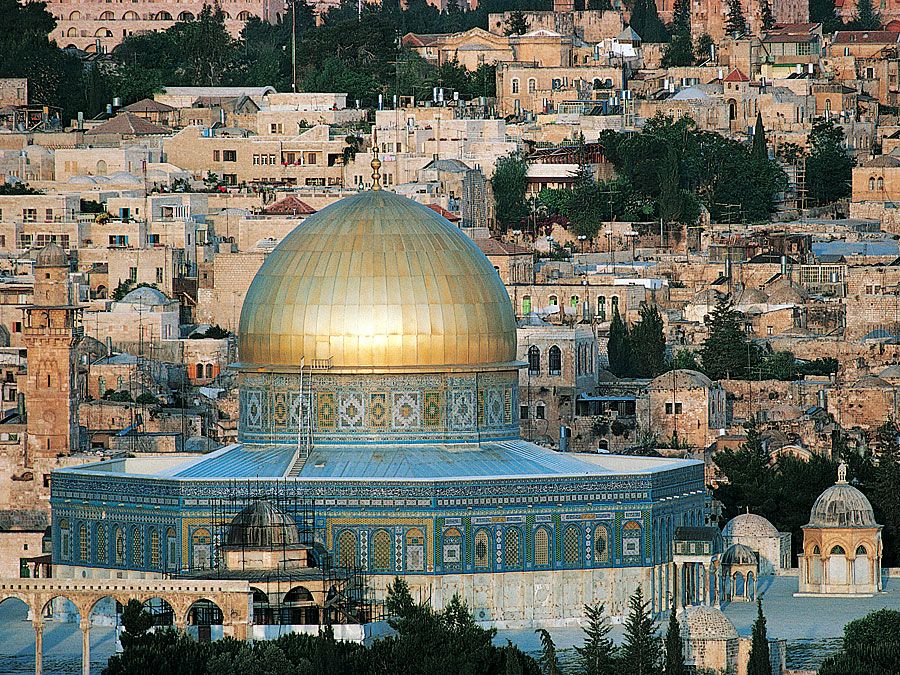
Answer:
51, 183, 706, 626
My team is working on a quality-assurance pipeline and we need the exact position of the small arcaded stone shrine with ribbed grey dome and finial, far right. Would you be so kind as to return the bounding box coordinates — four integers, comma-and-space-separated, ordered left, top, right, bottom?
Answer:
797, 462, 882, 597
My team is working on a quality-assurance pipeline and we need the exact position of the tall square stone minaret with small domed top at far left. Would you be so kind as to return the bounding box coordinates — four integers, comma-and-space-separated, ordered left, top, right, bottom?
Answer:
21, 243, 82, 466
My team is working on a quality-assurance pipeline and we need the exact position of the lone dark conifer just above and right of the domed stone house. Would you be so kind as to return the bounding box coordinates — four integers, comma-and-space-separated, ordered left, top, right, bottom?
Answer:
700, 295, 753, 380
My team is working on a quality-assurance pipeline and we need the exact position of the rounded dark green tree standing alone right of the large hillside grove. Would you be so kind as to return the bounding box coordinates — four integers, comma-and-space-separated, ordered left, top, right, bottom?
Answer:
806, 118, 854, 204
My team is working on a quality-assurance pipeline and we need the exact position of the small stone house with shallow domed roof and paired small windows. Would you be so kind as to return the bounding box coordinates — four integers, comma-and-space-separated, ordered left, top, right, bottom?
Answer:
645, 370, 727, 448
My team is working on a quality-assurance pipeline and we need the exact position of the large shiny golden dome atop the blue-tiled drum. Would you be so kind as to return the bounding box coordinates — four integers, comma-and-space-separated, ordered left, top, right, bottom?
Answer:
239, 190, 516, 371
